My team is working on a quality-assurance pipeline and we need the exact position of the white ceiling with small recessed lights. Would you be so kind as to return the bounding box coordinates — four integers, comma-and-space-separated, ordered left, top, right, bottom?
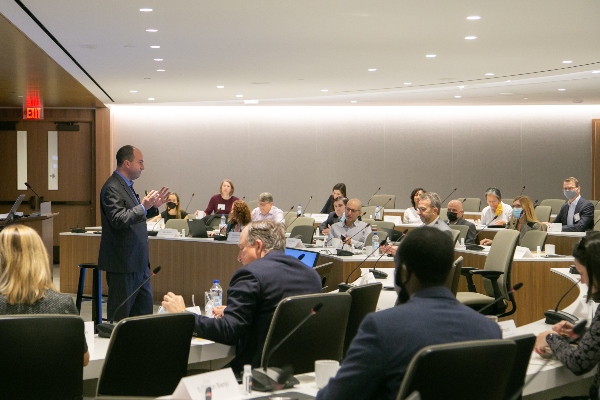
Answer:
0, 0, 600, 105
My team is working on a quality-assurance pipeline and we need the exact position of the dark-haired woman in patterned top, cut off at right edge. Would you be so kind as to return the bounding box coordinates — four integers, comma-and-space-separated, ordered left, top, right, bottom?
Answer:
535, 232, 600, 399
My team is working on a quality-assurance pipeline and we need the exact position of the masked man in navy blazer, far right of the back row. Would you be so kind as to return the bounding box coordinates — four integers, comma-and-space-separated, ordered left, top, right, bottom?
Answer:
554, 177, 594, 232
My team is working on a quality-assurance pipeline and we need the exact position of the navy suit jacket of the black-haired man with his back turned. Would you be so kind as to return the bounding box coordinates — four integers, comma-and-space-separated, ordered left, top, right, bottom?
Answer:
316, 286, 502, 400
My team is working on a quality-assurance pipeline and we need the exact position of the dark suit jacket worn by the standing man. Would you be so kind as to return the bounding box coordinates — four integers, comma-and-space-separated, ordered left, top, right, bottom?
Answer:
98, 172, 148, 273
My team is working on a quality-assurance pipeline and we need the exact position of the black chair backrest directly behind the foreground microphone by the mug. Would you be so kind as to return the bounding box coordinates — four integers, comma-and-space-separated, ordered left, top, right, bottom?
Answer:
261, 293, 352, 374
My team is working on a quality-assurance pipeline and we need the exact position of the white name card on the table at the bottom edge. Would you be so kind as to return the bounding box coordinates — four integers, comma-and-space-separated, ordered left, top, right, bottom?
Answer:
171, 368, 240, 400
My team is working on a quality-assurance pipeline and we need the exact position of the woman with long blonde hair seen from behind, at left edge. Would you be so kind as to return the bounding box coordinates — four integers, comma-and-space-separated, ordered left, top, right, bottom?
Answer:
0, 225, 90, 366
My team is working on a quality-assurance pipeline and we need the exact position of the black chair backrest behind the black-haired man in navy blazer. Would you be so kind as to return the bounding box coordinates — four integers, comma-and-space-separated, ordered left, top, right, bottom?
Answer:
397, 339, 517, 400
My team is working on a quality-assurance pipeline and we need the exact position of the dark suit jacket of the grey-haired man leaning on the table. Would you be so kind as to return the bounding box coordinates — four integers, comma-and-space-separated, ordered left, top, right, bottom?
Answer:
195, 250, 322, 373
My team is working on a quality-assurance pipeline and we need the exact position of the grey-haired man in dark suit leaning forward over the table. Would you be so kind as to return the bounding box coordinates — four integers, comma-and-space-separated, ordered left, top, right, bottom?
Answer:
162, 220, 322, 373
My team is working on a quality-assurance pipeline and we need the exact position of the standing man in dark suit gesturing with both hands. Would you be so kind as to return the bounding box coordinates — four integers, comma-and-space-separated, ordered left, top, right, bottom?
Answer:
98, 145, 169, 321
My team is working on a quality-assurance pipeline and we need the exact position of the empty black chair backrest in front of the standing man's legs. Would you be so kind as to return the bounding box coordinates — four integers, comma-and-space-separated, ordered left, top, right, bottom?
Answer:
97, 313, 194, 397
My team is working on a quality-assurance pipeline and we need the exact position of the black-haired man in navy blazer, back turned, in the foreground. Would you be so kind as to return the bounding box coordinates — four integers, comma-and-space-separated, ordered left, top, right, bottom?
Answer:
316, 228, 502, 400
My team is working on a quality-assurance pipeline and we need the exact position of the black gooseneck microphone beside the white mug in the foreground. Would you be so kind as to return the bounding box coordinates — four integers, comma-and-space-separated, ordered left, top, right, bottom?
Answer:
252, 303, 323, 392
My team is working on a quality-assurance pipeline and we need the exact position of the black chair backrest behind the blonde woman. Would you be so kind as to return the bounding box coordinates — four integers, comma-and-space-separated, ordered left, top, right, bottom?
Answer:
0, 315, 85, 399
